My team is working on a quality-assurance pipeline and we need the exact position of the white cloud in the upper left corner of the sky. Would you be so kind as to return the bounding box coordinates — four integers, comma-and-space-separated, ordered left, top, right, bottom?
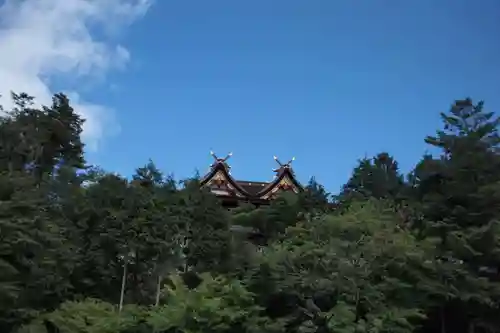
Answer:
0, 0, 152, 149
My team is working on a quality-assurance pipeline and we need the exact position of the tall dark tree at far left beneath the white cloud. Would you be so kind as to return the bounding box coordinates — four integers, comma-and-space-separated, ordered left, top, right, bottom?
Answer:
0, 94, 83, 331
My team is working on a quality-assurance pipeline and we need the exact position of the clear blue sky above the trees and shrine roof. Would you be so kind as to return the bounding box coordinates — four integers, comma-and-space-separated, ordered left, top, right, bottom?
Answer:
4, 0, 500, 192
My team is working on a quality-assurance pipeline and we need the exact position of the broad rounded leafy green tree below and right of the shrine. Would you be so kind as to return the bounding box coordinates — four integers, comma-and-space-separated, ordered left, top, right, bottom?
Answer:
250, 200, 418, 332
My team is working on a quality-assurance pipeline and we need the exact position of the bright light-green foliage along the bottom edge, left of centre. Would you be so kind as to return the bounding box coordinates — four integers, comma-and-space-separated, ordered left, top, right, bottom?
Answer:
18, 273, 283, 333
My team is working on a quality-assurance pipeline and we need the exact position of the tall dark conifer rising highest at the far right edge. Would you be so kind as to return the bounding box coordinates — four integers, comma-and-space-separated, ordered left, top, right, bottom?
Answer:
416, 99, 500, 271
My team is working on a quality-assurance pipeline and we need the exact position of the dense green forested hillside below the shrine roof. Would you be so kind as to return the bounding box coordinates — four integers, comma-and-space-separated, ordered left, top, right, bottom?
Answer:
0, 94, 500, 333
